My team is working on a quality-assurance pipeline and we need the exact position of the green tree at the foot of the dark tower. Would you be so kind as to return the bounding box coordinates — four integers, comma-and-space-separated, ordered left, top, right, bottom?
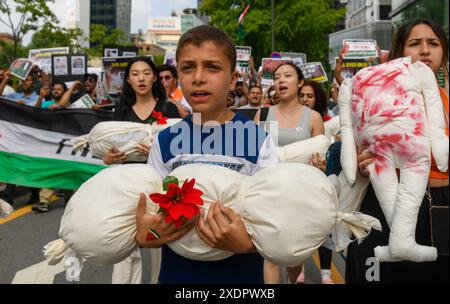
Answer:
87, 24, 133, 57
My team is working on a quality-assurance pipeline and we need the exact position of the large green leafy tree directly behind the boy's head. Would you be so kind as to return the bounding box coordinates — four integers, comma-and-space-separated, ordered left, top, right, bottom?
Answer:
200, 0, 345, 67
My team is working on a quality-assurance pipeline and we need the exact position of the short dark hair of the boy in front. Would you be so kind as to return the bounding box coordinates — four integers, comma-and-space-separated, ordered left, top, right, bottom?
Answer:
175, 25, 236, 73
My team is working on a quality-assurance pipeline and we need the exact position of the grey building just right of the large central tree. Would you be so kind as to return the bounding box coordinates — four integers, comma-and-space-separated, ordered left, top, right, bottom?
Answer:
328, 0, 395, 68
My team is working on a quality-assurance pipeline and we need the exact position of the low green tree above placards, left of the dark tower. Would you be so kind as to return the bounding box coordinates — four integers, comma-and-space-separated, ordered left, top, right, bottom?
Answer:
29, 24, 88, 53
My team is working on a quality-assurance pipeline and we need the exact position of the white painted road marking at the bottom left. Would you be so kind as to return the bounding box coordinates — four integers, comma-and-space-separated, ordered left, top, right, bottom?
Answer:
11, 261, 64, 284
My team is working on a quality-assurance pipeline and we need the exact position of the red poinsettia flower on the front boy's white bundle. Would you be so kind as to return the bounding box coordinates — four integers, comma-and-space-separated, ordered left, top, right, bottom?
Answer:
150, 178, 203, 227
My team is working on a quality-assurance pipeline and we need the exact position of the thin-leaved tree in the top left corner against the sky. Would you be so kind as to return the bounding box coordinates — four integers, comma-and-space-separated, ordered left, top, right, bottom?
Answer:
0, 0, 58, 58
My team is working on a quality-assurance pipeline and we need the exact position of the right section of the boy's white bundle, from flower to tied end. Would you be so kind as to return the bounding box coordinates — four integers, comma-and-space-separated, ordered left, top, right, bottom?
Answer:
168, 163, 381, 266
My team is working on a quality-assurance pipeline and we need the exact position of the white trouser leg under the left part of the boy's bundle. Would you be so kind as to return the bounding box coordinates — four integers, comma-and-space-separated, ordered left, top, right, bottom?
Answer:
112, 247, 142, 284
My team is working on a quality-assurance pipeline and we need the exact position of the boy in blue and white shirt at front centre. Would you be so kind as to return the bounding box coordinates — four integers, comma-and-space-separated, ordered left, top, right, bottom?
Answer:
136, 26, 278, 283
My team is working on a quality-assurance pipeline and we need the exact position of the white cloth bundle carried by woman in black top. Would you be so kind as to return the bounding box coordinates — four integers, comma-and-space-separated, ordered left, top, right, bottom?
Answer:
72, 118, 180, 161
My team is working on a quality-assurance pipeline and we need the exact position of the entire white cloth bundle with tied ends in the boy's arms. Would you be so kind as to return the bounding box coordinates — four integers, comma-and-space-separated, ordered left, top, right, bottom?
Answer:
45, 163, 380, 266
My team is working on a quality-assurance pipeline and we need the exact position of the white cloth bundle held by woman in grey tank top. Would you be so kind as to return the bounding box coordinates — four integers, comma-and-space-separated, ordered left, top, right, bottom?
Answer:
278, 135, 331, 164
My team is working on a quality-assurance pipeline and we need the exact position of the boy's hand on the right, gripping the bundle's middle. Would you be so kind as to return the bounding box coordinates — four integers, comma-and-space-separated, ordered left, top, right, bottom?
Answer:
195, 202, 256, 253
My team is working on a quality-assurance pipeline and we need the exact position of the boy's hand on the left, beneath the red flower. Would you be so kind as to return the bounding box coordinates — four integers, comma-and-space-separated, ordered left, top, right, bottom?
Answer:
135, 193, 194, 248
